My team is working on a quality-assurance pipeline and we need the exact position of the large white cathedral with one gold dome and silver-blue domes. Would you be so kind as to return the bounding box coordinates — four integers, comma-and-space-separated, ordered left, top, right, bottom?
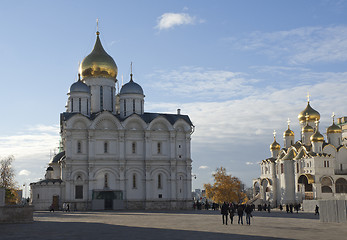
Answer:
30, 31, 194, 210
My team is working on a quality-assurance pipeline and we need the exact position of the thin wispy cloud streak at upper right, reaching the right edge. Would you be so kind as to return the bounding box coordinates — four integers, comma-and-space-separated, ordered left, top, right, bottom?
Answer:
225, 26, 347, 65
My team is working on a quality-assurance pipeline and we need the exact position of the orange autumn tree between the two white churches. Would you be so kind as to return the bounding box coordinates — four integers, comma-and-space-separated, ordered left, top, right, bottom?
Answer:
204, 167, 248, 203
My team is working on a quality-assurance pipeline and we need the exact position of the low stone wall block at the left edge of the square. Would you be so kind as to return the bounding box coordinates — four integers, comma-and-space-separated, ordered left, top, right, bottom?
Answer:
0, 206, 34, 223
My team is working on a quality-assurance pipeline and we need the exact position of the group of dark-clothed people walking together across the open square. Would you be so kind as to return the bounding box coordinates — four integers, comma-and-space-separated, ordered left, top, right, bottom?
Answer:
221, 202, 254, 225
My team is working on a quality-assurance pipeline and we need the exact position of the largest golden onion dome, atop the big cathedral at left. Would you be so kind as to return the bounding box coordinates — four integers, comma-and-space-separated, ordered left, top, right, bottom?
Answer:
79, 32, 118, 80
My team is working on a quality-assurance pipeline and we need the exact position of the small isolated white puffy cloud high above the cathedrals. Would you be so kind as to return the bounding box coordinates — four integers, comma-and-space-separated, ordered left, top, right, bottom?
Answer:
156, 13, 196, 30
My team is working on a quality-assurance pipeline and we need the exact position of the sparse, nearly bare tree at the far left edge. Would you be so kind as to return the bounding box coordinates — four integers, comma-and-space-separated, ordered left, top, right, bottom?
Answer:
0, 156, 18, 204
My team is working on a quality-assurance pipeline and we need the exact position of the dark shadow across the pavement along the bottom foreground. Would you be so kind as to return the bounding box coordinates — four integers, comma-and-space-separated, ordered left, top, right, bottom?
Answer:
0, 222, 285, 240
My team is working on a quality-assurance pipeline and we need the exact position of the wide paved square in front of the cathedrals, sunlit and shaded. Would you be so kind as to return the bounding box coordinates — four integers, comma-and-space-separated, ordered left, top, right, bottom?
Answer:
0, 210, 347, 240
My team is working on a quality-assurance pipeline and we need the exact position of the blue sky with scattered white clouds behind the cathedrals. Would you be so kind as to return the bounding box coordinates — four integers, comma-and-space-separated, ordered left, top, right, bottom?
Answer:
0, 0, 347, 197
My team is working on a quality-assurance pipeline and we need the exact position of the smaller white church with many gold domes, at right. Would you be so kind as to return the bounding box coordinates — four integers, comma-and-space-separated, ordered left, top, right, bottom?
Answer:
253, 100, 347, 207
